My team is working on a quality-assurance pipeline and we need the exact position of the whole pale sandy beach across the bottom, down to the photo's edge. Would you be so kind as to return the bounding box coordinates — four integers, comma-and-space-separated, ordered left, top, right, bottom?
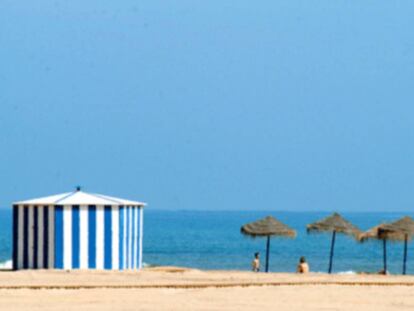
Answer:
0, 267, 414, 311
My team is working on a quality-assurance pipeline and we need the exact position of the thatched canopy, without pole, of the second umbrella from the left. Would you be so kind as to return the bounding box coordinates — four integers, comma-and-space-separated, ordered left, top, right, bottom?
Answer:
306, 213, 361, 237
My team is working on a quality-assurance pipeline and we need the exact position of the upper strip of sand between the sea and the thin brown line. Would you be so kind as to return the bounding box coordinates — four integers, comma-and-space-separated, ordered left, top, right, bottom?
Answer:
0, 267, 414, 290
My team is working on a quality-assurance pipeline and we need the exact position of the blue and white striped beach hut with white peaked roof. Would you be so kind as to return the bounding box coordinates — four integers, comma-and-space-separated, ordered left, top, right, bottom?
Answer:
13, 188, 145, 270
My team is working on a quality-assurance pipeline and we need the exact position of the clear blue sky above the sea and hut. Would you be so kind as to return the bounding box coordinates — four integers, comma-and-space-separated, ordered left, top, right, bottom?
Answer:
0, 0, 414, 211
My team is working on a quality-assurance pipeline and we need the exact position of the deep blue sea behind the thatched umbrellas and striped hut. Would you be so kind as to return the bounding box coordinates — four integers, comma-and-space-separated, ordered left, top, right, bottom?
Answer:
0, 208, 414, 274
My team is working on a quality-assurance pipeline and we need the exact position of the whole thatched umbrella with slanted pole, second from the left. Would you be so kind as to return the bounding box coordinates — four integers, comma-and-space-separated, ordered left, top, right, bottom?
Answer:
306, 213, 361, 273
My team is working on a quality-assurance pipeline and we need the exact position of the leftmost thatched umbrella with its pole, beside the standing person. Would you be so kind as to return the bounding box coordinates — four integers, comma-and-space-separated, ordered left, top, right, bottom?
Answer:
240, 216, 296, 272
